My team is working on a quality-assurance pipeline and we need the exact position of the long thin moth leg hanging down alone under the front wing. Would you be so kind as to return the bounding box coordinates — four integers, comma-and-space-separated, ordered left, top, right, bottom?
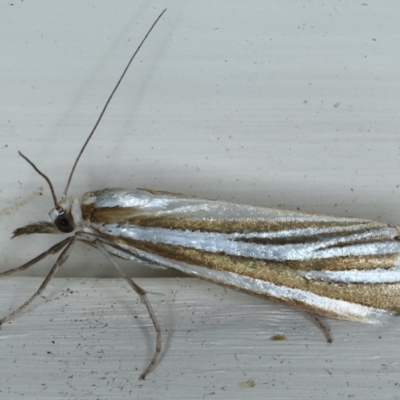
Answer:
93, 239, 161, 380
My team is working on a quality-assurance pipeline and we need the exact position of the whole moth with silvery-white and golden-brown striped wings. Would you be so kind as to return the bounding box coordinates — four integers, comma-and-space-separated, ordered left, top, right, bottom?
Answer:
0, 10, 400, 379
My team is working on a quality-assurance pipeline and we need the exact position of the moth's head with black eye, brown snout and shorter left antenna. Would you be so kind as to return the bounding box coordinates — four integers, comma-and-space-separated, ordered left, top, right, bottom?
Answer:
12, 152, 75, 238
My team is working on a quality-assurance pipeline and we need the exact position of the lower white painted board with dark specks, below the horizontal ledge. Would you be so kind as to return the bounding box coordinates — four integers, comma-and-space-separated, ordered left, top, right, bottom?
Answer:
0, 277, 400, 400
